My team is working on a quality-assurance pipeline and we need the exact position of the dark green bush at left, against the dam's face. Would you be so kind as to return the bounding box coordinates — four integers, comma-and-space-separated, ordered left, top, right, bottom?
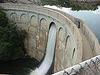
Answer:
0, 8, 26, 61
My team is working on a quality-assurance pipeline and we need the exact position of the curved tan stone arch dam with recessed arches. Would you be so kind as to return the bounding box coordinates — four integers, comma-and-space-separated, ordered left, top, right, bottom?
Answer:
0, 3, 100, 72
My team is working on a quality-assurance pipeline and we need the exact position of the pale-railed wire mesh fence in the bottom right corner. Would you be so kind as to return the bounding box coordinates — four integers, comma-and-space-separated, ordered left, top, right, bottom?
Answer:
53, 55, 100, 75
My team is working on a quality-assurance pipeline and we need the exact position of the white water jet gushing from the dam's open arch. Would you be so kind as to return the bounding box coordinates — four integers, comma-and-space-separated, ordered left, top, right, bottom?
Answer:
30, 23, 56, 75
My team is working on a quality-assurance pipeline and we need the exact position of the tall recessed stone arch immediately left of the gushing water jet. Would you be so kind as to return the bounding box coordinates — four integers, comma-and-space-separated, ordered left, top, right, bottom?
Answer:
38, 18, 48, 60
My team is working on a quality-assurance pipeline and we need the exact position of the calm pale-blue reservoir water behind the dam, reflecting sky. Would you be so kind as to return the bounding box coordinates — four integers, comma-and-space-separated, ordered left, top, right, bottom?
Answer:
45, 5, 100, 42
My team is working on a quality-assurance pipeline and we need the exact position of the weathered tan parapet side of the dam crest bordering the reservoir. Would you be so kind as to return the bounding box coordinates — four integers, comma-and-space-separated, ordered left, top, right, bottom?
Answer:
49, 8, 100, 61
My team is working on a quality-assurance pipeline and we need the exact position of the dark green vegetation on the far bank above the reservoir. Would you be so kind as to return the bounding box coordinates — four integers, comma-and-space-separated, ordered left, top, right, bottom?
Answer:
41, 0, 100, 11
